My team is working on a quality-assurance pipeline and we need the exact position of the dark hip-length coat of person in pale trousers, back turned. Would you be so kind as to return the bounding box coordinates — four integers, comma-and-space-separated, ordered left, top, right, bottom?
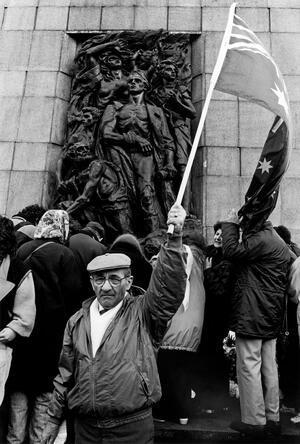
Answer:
222, 222, 290, 339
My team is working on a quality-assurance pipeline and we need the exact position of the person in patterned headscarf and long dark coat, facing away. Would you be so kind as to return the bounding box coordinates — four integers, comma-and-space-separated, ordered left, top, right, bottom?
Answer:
6, 210, 79, 444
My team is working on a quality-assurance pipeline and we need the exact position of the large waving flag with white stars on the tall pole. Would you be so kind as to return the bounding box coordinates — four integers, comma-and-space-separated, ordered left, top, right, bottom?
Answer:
215, 4, 291, 229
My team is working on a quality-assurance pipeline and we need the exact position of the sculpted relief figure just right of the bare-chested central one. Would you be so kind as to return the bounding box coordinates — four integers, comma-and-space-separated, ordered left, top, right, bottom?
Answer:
151, 60, 196, 211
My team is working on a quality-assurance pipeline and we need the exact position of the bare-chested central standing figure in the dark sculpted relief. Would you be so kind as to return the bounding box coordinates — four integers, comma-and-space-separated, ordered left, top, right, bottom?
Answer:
100, 70, 175, 234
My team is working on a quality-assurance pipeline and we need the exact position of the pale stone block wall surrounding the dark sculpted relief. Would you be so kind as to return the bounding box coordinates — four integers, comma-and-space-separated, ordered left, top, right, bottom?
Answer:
0, 0, 300, 241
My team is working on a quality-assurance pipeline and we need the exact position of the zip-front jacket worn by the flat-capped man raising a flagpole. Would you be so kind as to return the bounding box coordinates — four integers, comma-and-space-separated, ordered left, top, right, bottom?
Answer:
48, 238, 186, 427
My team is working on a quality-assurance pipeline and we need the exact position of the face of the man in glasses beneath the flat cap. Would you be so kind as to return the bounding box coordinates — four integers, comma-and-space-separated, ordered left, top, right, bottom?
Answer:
91, 268, 132, 310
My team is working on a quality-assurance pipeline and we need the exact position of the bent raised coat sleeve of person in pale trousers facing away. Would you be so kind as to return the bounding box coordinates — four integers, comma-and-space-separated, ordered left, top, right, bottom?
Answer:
222, 222, 262, 262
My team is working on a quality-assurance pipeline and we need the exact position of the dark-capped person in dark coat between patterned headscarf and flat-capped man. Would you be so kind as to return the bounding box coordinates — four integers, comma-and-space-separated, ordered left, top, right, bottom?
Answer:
69, 222, 107, 303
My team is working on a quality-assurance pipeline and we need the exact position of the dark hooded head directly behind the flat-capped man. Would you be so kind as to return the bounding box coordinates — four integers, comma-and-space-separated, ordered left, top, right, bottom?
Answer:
109, 233, 152, 291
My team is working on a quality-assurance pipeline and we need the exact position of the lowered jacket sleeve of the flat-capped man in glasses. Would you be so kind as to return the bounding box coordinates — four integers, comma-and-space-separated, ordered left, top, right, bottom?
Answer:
48, 318, 74, 422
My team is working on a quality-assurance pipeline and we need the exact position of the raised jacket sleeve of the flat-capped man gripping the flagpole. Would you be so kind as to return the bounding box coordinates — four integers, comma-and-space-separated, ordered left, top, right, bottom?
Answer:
142, 237, 187, 343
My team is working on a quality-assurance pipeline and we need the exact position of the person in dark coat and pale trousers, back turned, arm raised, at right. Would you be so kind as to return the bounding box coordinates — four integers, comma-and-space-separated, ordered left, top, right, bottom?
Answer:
222, 210, 290, 435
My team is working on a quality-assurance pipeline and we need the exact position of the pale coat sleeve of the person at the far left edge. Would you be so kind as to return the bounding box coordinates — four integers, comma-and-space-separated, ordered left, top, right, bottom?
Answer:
7, 271, 36, 337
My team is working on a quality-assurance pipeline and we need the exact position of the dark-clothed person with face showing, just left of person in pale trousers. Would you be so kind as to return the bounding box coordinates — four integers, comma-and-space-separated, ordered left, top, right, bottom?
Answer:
199, 222, 233, 414
